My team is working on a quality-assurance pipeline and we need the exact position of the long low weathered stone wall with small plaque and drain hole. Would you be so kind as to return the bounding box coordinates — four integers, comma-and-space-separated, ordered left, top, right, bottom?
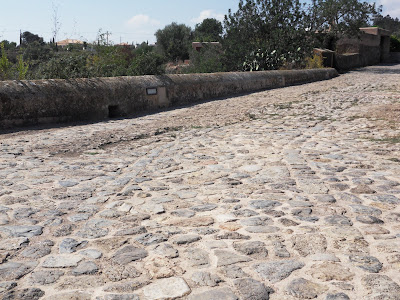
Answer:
0, 69, 337, 129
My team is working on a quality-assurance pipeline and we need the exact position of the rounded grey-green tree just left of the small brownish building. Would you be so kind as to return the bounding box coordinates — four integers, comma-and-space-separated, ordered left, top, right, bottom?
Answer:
155, 22, 192, 61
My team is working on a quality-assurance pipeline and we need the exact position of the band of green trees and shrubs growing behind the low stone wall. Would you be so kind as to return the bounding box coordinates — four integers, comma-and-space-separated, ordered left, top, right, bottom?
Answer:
0, 0, 394, 80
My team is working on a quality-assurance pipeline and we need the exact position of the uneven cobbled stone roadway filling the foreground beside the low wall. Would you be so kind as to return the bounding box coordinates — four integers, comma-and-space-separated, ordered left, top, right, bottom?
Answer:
0, 65, 400, 300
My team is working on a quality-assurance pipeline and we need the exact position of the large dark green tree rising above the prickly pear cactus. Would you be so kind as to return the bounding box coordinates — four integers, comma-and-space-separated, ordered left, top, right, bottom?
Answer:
223, 0, 312, 70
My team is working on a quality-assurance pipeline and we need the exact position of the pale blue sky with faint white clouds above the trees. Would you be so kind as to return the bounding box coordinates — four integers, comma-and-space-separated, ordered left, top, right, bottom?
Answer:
0, 0, 400, 43
